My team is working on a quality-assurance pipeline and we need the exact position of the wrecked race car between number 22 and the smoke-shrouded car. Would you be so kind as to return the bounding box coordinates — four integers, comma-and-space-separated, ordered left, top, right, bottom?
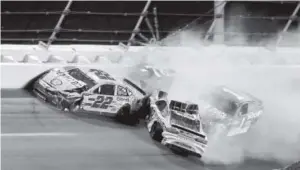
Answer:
139, 90, 208, 157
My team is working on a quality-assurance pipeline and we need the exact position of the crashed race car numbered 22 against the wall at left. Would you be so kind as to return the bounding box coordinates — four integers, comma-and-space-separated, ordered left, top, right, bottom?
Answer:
33, 66, 145, 125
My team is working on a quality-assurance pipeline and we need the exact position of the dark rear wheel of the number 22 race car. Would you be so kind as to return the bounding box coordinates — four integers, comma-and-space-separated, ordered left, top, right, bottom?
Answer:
116, 105, 139, 126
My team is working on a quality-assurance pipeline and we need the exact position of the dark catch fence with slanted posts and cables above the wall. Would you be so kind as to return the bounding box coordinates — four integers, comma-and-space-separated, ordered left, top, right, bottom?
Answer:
1, 0, 300, 47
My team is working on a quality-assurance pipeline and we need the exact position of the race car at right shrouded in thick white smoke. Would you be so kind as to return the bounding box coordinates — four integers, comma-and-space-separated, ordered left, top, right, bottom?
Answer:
199, 86, 263, 136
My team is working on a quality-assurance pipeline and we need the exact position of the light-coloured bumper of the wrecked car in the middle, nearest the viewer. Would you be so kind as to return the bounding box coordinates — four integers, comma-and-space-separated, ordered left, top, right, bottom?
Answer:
161, 131, 206, 156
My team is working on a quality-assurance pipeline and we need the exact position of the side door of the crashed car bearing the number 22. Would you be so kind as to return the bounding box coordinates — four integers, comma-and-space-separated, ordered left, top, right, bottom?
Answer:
82, 84, 116, 112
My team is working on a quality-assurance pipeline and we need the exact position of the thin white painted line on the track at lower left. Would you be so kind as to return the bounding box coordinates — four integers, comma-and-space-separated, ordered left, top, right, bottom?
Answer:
1, 132, 77, 137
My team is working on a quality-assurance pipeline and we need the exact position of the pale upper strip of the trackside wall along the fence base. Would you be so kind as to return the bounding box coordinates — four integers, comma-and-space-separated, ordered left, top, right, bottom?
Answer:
1, 45, 300, 65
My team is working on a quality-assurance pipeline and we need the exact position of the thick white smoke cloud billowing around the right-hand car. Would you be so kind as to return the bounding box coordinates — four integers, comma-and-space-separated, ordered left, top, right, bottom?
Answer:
119, 2, 300, 163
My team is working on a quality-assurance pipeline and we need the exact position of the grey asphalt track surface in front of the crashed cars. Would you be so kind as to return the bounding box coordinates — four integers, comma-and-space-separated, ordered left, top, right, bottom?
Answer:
1, 90, 281, 170
